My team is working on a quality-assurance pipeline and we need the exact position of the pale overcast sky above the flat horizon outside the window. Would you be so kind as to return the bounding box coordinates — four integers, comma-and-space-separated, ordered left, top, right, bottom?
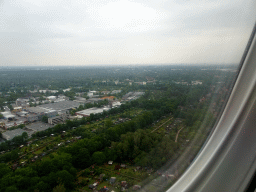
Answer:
0, 0, 256, 66
